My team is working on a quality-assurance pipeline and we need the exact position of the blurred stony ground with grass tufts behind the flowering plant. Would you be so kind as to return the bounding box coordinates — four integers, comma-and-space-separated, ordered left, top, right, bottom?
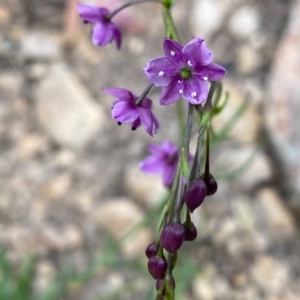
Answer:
0, 0, 300, 300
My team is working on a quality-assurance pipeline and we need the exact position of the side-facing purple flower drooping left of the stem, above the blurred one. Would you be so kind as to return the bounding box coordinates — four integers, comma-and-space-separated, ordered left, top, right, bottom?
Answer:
103, 88, 159, 136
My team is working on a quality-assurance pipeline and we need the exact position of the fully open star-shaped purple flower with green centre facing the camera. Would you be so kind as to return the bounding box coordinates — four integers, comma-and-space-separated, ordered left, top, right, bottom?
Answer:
144, 38, 226, 105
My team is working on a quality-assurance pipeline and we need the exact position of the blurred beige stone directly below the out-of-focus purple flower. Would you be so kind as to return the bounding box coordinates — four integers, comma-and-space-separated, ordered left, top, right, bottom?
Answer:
125, 163, 166, 208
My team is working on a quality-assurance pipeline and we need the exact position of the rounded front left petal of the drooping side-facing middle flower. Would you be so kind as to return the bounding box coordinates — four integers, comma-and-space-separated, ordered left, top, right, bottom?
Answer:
111, 101, 138, 123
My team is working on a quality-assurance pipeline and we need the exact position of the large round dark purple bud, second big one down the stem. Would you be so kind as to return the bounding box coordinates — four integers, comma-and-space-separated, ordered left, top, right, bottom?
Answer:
160, 223, 184, 253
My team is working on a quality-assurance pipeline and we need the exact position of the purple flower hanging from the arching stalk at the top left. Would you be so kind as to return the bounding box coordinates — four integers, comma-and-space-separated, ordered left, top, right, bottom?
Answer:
77, 4, 122, 49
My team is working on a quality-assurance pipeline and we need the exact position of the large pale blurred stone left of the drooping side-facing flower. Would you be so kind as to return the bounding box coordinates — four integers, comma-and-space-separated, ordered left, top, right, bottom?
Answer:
35, 63, 105, 148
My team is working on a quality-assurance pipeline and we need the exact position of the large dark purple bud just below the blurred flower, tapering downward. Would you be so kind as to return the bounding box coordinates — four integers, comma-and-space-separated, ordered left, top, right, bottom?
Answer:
183, 178, 207, 212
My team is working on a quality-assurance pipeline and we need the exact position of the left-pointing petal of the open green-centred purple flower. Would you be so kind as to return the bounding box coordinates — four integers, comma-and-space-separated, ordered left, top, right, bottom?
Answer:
144, 56, 180, 86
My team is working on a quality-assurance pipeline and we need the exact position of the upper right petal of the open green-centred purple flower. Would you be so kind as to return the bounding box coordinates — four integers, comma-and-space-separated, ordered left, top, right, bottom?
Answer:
182, 38, 213, 66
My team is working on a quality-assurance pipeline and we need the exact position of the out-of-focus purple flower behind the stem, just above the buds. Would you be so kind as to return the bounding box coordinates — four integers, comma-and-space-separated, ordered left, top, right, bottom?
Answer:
140, 142, 179, 187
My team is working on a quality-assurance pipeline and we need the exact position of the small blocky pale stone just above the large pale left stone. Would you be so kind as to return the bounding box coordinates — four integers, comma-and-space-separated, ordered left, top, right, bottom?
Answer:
21, 30, 60, 60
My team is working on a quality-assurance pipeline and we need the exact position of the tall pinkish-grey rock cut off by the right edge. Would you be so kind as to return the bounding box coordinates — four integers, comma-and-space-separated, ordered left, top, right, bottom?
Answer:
264, 1, 300, 211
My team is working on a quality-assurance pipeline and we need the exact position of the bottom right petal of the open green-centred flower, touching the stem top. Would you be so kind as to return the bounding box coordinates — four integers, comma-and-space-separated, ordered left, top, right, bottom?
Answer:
182, 76, 208, 104
